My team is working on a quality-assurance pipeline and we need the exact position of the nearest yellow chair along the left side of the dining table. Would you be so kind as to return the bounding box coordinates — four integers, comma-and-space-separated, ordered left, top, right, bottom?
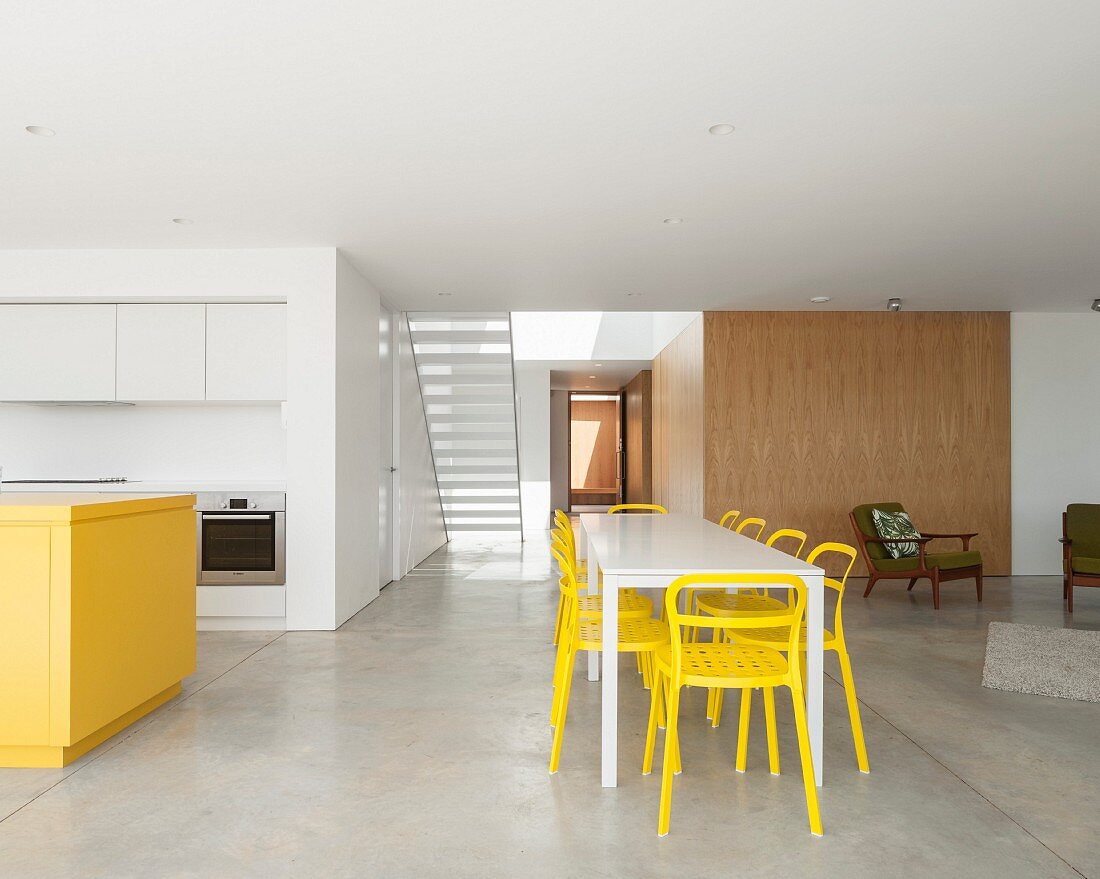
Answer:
550, 547, 669, 774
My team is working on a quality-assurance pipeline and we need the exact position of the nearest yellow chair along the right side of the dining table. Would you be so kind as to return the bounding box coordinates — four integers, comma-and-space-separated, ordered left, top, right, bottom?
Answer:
715, 543, 871, 774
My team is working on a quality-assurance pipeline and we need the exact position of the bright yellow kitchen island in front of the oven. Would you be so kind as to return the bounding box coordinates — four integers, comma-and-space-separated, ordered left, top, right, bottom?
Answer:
0, 493, 195, 767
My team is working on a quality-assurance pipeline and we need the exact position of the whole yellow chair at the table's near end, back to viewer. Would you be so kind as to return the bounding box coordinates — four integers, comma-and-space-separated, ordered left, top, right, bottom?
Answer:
641, 573, 822, 836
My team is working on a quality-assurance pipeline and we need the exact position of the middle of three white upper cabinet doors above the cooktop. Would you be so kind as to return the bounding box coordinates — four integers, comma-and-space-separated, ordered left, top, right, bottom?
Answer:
117, 305, 207, 402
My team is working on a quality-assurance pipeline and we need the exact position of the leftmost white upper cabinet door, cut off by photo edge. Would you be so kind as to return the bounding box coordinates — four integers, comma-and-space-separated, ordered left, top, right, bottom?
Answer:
0, 305, 116, 400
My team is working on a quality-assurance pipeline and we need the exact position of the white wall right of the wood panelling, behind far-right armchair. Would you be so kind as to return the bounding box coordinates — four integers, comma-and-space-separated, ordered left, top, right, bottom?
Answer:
1012, 314, 1100, 574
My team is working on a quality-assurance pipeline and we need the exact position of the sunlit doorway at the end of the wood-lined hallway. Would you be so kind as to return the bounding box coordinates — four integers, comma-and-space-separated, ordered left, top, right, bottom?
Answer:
569, 393, 624, 512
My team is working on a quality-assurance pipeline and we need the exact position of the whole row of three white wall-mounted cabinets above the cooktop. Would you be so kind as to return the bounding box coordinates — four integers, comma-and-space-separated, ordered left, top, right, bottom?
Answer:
0, 303, 286, 403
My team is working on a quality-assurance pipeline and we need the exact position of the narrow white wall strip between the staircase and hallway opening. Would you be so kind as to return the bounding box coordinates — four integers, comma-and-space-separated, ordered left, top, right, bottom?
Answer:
516, 361, 550, 535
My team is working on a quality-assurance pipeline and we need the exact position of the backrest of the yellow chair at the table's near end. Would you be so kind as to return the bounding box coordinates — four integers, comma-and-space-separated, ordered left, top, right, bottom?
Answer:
664, 573, 806, 681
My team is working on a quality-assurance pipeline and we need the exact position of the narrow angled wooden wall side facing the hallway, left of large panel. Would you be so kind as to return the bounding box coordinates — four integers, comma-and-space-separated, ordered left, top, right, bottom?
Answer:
653, 316, 705, 516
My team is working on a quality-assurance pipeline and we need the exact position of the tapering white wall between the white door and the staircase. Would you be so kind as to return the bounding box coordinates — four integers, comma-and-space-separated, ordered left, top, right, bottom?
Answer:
397, 315, 447, 576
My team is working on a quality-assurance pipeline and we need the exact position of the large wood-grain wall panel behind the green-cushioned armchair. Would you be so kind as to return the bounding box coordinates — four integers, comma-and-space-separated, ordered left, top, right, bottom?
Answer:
705, 311, 1011, 574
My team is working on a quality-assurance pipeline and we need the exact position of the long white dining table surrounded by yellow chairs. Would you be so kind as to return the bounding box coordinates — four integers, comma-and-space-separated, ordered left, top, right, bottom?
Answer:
581, 513, 825, 788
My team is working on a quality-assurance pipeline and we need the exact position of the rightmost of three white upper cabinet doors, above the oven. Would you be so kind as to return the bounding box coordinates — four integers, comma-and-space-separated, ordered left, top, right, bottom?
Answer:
206, 305, 286, 400
